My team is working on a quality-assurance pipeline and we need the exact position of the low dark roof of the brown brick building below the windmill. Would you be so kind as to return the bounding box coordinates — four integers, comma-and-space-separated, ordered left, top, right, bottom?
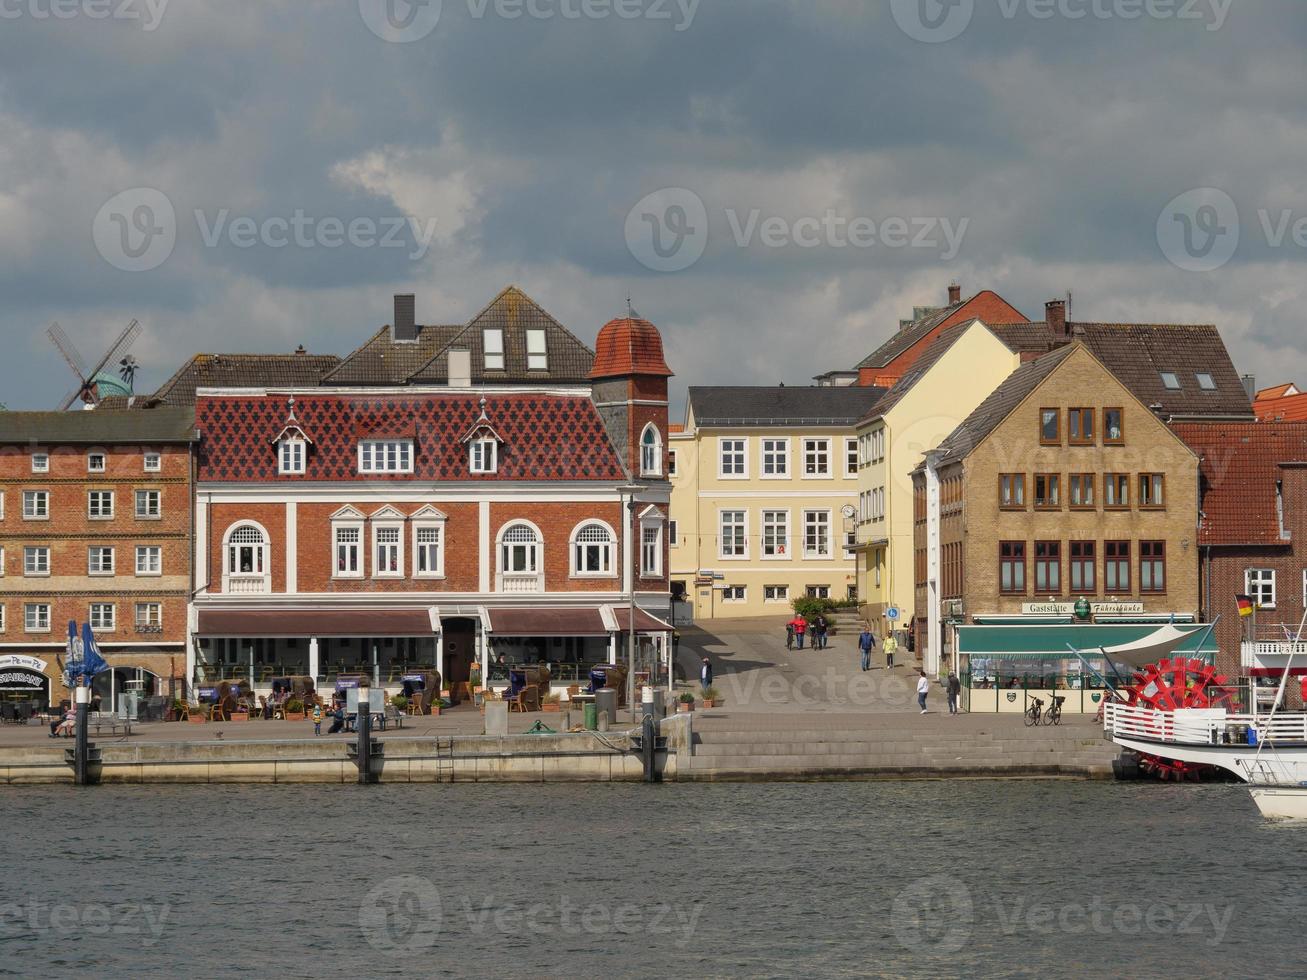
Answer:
0, 408, 195, 446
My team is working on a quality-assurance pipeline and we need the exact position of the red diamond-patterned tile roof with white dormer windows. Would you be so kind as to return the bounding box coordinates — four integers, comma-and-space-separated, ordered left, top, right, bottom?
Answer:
195, 392, 625, 483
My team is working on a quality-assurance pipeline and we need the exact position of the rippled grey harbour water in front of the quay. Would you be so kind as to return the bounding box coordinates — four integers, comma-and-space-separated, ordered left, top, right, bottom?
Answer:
0, 781, 1307, 977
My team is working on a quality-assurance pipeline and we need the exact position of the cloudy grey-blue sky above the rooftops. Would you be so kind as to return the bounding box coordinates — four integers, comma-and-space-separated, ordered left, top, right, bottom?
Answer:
0, 0, 1307, 417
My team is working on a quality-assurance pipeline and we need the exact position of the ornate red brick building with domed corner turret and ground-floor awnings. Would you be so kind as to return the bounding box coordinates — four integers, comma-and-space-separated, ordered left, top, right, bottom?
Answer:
190, 314, 672, 693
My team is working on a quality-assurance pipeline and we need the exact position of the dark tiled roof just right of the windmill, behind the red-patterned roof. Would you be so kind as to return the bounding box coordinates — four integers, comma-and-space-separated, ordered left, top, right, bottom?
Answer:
101, 353, 340, 409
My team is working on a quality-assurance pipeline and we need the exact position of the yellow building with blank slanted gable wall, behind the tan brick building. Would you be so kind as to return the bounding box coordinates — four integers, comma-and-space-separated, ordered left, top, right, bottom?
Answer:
856, 320, 1047, 635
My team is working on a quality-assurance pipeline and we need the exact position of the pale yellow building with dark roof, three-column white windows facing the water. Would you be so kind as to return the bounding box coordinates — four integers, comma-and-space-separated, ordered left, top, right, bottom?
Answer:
668, 386, 888, 619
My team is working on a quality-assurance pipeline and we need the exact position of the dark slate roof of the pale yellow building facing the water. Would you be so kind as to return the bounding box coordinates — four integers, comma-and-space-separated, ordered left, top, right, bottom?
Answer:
690, 387, 886, 427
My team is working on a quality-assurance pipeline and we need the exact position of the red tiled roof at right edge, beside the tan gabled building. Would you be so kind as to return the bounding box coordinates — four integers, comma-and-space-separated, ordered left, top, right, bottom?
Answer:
1171, 422, 1307, 545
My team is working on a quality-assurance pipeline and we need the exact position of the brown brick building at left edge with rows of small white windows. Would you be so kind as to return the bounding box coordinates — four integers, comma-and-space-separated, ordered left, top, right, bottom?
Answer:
0, 409, 195, 711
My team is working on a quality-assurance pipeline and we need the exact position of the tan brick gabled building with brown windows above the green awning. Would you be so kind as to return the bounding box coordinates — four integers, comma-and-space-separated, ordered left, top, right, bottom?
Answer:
914, 342, 1200, 665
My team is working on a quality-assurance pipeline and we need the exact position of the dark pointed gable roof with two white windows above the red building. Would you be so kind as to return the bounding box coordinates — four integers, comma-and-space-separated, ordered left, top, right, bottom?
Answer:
408, 286, 595, 384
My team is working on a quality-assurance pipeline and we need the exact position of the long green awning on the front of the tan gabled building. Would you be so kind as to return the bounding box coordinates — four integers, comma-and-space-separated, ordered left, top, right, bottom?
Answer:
958, 623, 1217, 660
